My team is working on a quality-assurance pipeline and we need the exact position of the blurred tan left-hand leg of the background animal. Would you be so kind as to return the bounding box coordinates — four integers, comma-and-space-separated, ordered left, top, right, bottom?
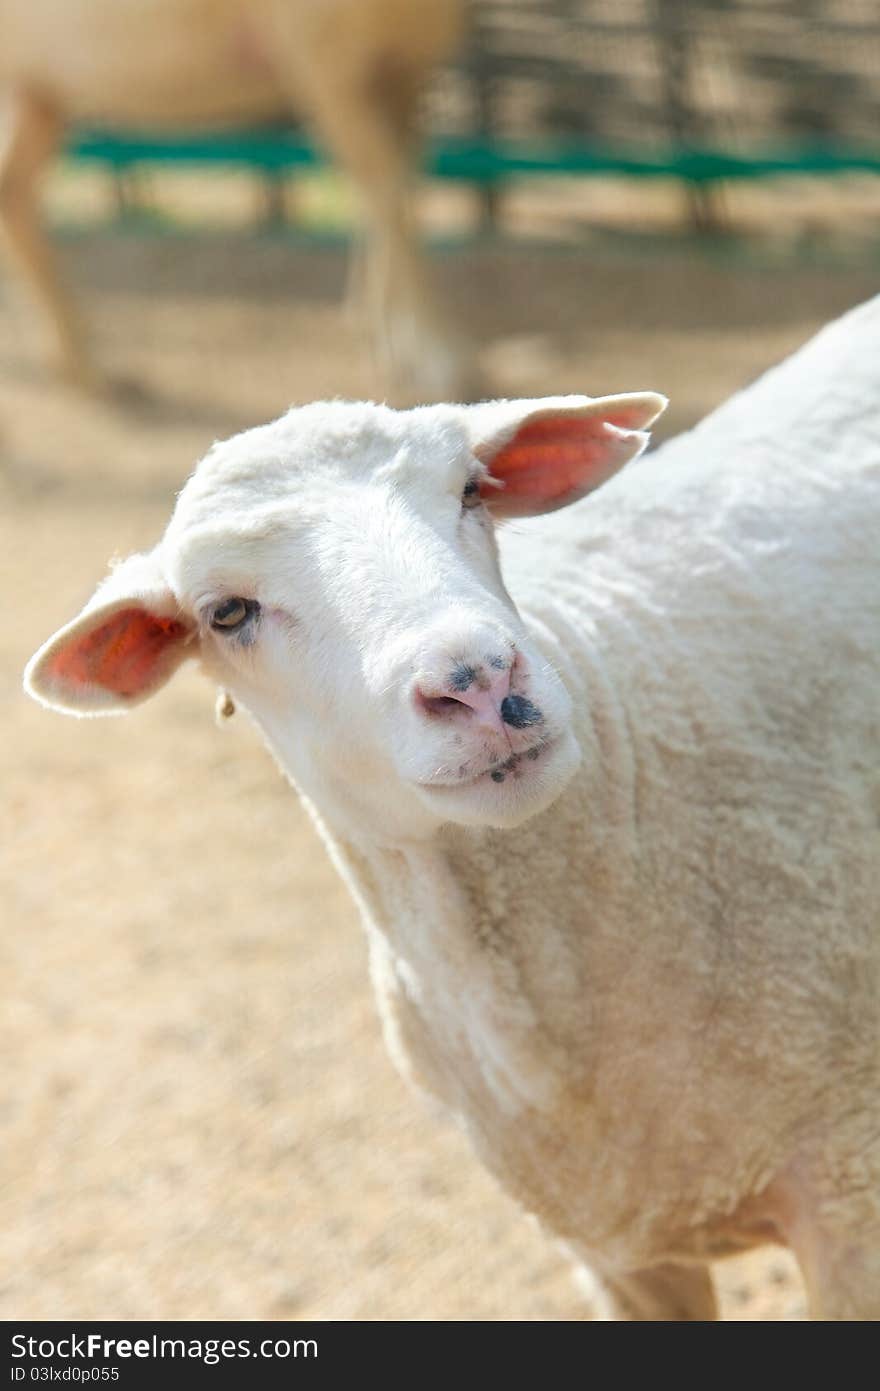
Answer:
0, 90, 95, 387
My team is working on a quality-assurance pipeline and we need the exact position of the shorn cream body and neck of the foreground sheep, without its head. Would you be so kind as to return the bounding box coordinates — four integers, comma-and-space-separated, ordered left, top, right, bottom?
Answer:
322, 300, 880, 1299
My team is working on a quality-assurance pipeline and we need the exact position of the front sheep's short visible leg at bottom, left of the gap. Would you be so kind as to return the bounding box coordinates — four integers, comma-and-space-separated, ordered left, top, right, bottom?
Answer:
581, 1263, 719, 1323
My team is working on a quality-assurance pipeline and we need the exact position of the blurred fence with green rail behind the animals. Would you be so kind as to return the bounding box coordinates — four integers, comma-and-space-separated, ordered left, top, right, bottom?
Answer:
71, 0, 880, 205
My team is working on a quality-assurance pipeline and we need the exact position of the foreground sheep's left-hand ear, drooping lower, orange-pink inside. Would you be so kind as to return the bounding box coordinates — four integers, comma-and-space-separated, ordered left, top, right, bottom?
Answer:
25, 555, 196, 715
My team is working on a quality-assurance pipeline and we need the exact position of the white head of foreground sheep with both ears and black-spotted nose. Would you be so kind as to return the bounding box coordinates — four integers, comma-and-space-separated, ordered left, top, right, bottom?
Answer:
26, 394, 663, 842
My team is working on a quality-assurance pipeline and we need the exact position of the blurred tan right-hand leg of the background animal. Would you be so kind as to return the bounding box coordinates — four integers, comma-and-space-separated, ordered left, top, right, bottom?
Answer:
283, 64, 475, 402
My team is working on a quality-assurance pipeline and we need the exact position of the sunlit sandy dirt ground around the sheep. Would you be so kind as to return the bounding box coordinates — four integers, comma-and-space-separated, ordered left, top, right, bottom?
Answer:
0, 203, 877, 1320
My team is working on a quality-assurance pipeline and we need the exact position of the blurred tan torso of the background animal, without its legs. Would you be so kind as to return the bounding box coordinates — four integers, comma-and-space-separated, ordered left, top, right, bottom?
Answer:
0, 0, 463, 129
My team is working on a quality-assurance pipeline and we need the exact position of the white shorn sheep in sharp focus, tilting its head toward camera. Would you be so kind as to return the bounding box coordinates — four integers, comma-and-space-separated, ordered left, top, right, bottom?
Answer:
26, 299, 880, 1319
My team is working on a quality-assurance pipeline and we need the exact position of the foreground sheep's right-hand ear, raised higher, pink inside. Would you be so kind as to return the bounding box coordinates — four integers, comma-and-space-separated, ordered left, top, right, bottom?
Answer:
467, 391, 667, 517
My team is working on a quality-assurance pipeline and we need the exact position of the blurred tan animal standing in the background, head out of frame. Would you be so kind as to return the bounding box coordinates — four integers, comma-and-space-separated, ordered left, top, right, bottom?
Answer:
0, 0, 474, 401
